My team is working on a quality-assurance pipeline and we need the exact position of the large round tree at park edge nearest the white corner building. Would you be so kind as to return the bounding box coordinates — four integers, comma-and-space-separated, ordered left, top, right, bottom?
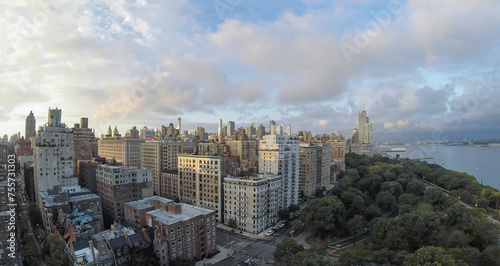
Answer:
302, 196, 344, 233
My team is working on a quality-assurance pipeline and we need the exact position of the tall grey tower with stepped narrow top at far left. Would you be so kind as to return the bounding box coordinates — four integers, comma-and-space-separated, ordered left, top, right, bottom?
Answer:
33, 108, 78, 203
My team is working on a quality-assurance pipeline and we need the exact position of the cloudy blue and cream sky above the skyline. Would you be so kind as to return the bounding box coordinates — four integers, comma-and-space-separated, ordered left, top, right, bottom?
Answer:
0, 0, 500, 142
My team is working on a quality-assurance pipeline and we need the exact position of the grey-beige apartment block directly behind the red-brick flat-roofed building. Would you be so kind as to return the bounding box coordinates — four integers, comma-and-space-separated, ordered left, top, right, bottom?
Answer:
96, 164, 153, 221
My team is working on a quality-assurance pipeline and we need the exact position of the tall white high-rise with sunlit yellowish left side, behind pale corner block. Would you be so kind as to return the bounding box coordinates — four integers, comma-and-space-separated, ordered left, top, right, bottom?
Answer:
259, 135, 300, 208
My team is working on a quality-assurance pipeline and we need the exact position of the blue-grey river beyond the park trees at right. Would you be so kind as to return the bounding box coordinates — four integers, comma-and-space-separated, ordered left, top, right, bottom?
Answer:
389, 145, 500, 189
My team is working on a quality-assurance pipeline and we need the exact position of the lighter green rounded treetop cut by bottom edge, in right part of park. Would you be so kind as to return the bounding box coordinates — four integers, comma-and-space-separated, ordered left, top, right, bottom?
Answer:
403, 246, 456, 266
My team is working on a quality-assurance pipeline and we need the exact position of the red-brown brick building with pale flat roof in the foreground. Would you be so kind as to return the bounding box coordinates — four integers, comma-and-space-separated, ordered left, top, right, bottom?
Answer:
124, 196, 217, 265
